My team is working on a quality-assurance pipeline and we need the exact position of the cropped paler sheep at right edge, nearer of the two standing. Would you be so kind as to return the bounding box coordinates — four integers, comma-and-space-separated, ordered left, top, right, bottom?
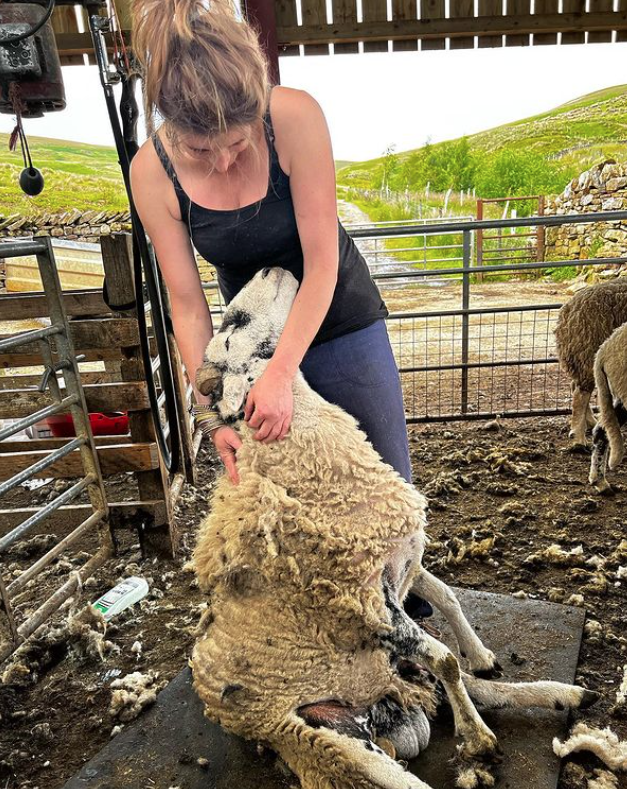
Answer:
589, 323, 627, 489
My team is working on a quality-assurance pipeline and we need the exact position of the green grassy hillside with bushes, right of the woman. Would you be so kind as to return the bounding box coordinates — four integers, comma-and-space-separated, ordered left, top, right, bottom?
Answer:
338, 85, 627, 197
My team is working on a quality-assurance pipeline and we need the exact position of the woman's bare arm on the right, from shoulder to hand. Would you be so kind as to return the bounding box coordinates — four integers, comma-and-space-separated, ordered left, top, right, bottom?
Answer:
245, 88, 339, 441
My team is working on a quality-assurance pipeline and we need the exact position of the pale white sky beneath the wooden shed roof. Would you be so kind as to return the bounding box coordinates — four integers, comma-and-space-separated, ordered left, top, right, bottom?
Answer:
0, 43, 627, 161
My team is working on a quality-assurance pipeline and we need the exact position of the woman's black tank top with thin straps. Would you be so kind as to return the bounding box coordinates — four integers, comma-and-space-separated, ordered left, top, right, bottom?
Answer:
152, 101, 388, 346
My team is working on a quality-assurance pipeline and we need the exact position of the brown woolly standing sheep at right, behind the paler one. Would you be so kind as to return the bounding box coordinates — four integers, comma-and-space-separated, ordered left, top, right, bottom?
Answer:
555, 281, 627, 446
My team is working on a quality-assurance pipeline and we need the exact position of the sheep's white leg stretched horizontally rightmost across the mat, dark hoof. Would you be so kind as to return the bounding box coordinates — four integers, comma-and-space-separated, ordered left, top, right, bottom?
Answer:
462, 674, 599, 710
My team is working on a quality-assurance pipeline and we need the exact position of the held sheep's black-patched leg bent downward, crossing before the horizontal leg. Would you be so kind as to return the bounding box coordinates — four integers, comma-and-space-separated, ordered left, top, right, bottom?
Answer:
380, 573, 497, 758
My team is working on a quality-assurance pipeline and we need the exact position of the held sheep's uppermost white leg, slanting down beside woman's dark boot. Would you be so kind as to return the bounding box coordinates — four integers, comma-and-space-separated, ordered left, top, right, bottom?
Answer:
412, 568, 501, 677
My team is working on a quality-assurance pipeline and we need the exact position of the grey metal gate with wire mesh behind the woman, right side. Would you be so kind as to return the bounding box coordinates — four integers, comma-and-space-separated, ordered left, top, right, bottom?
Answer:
351, 206, 627, 422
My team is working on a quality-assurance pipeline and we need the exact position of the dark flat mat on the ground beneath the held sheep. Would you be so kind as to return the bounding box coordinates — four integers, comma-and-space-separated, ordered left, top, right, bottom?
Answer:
64, 590, 584, 789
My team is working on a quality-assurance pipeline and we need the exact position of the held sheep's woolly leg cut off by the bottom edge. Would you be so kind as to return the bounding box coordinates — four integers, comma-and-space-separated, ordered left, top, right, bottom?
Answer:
280, 705, 431, 789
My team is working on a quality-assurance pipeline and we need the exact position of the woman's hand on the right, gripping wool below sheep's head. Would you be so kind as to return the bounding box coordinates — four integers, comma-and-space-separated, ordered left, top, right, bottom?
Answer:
244, 368, 294, 444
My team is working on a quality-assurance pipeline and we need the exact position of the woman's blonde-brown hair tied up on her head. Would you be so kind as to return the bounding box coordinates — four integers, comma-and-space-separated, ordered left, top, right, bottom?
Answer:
133, 0, 270, 145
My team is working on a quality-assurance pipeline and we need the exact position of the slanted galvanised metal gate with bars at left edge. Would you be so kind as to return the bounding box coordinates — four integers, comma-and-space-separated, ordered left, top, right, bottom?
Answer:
0, 238, 113, 661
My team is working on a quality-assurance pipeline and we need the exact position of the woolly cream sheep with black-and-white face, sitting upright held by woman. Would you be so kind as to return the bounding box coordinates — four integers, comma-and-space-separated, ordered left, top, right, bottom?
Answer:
192, 268, 595, 789
